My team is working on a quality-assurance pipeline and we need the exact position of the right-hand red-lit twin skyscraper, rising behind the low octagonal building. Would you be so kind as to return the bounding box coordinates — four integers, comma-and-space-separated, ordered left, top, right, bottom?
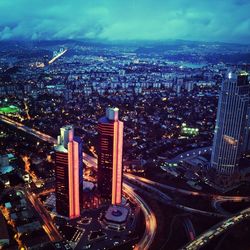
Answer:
97, 108, 123, 205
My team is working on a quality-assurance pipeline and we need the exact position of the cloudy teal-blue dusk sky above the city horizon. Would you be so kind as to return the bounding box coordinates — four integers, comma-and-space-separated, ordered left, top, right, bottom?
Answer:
0, 0, 250, 43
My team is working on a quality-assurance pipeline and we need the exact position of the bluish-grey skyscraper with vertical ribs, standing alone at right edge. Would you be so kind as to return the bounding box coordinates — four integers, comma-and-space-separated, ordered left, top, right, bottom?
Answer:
211, 72, 250, 175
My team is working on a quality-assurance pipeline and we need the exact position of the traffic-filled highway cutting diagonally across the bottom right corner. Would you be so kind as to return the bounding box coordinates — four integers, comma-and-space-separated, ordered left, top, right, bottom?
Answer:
182, 208, 250, 250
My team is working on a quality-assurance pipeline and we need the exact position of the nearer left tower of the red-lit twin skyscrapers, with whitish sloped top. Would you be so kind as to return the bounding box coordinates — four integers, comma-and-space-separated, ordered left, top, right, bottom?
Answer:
55, 126, 83, 218
